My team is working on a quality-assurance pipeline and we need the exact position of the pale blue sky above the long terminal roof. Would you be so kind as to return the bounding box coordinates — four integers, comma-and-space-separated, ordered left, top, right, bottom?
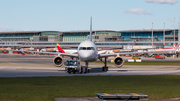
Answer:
0, 0, 180, 32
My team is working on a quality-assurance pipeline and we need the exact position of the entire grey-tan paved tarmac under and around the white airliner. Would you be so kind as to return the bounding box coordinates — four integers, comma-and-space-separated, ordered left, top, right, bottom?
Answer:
0, 55, 180, 77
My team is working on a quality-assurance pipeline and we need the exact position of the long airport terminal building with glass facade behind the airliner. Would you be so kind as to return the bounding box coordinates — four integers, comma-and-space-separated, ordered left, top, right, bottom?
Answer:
0, 29, 178, 48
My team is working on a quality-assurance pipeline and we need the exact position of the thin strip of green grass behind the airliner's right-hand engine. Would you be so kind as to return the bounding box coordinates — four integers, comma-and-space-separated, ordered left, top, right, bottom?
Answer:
94, 61, 180, 66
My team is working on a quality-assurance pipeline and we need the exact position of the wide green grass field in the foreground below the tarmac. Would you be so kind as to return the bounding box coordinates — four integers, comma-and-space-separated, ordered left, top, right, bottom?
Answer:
0, 75, 180, 101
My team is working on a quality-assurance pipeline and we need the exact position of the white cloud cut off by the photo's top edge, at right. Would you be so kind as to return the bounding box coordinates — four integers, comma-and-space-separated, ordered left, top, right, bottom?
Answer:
144, 0, 178, 4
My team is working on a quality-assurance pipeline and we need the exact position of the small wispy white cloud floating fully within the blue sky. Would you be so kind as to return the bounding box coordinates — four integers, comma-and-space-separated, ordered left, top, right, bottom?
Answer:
125, 8, 152, 15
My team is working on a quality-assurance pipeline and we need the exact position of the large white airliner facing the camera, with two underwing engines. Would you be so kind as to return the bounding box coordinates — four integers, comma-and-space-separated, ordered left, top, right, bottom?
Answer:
2, 18, 175, 71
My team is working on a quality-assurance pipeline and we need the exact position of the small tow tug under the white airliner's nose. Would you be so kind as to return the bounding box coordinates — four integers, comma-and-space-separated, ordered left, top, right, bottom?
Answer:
65, 60, 89, 74
